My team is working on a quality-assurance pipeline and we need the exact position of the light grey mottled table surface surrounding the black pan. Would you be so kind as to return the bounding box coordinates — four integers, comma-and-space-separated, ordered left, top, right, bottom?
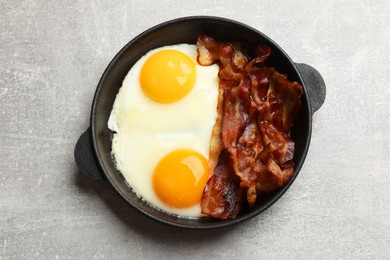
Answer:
0, 0, 390, 259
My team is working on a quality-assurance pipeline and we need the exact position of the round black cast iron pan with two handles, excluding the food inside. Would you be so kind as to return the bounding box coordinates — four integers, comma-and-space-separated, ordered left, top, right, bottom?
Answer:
75, 16, 325, 229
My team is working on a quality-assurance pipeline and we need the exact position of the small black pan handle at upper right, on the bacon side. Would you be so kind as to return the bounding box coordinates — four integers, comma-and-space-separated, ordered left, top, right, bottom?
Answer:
295, 63, 326, 113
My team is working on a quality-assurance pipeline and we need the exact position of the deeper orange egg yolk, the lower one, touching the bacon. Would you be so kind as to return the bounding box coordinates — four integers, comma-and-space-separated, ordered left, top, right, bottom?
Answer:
152, 149, 209, 208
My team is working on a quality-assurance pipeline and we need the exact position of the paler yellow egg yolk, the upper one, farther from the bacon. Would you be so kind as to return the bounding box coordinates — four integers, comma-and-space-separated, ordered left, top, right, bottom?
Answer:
140, 50, 196, 103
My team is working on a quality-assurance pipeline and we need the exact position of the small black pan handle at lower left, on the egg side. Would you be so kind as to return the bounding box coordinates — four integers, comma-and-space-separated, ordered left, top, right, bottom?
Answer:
74, 127, 104, 180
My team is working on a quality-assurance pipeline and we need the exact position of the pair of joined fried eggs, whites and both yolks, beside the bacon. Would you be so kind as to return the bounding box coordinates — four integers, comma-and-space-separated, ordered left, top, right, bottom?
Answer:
108, 44, 219, 217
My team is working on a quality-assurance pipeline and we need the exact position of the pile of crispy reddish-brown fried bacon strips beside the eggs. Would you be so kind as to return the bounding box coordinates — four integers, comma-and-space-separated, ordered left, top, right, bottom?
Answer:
197, 35, 303, 219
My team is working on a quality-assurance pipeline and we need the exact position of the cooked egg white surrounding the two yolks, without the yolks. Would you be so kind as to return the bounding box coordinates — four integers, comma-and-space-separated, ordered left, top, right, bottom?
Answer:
108, 44, 219, 217
